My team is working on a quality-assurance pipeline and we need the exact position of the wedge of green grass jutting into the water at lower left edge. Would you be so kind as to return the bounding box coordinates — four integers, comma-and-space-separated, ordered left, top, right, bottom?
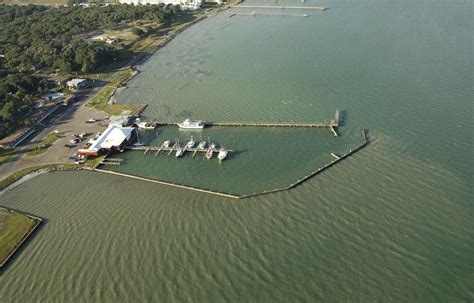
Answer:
0, 208, 38, 266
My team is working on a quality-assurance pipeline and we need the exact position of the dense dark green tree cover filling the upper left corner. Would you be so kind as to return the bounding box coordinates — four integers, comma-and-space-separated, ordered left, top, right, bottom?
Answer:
0, 4, 180, 136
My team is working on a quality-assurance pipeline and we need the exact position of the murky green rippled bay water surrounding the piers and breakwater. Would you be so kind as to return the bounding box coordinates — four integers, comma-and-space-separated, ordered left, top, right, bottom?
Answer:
0, 1, 474, 302
